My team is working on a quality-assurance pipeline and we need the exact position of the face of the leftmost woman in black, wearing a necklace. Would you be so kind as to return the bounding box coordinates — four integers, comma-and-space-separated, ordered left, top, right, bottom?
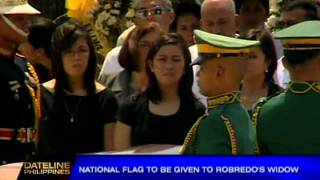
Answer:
62, 37, 90, 77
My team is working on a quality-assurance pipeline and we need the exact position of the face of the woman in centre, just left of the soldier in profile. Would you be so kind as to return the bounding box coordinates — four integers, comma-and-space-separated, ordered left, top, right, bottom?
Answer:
149, 45, 186, 85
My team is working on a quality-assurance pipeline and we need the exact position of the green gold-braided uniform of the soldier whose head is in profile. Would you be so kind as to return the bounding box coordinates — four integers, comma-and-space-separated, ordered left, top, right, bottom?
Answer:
181, 92, 255, 155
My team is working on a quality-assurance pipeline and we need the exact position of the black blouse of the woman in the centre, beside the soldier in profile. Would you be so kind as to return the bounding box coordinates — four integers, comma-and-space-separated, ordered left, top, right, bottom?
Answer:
120, 96, 205, 146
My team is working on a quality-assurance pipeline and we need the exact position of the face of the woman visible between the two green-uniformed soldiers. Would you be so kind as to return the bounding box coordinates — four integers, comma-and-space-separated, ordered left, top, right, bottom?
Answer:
245, 48, 269, 79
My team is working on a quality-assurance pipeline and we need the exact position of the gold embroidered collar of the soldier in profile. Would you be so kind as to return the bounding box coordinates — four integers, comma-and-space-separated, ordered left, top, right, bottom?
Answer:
207, 91, 240, 109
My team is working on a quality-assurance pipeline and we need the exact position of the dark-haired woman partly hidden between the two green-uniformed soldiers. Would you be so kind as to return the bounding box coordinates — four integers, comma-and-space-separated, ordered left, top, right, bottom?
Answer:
241, 28, 281, 111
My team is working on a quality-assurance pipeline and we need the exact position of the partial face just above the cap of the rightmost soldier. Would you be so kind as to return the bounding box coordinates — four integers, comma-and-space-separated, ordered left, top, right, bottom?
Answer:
279, 8, 306, 28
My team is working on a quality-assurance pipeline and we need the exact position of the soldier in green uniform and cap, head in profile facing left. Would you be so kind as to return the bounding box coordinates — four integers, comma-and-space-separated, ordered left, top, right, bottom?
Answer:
180, 30, 259, 155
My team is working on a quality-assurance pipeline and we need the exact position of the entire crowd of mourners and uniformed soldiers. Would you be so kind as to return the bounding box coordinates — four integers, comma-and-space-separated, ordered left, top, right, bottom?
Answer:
0, 0, 320, 165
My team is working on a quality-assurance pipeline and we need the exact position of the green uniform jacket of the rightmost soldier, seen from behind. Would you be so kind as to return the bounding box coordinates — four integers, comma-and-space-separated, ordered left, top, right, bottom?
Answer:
257, 82, 320, 154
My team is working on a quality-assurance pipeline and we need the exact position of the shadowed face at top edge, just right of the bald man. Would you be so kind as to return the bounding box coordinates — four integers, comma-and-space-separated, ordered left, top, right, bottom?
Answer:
240, 0, 267, 31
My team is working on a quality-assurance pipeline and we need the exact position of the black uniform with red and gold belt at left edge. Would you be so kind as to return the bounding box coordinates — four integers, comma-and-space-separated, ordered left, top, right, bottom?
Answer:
0, 55, 35, 165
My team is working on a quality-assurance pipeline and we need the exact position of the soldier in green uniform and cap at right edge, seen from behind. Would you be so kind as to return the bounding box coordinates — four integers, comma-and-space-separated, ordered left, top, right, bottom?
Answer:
253, 21, 320, 154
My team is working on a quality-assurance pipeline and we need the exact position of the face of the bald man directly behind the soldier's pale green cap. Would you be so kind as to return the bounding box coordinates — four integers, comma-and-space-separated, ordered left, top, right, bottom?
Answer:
201, 4, 237, 37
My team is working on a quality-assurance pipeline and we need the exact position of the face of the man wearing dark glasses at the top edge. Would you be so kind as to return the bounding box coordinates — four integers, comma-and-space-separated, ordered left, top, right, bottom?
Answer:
135, 0, 174, 31
